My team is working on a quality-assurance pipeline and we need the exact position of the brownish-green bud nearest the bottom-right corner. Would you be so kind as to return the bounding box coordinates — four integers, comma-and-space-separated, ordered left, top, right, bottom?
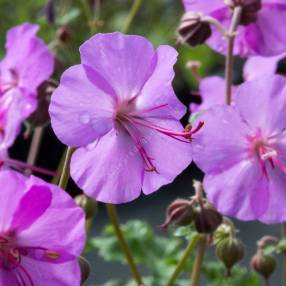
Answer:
250, 250, 276, 280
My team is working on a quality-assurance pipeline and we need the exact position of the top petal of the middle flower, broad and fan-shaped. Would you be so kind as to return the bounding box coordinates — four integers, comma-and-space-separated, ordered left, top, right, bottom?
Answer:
80, 32, 156, 99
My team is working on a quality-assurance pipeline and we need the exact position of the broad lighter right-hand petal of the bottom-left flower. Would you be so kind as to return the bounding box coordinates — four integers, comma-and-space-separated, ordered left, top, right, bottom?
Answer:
18, 176, 85, 256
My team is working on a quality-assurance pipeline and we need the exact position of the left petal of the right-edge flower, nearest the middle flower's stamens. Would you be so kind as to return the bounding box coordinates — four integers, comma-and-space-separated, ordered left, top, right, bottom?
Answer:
193, 105, 250, 174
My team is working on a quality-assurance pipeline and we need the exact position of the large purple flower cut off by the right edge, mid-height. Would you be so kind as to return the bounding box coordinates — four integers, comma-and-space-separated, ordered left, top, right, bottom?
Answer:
193, 75, 286, 223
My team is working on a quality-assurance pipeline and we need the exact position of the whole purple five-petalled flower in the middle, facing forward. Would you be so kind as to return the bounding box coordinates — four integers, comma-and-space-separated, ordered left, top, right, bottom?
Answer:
50, 33, 199, 203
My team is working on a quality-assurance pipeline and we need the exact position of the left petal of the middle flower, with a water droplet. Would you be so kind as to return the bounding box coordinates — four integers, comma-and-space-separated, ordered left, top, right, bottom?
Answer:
49, 65, 115, 146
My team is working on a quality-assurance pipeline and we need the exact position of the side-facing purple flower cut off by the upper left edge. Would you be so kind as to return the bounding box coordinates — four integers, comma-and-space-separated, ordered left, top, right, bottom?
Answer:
0, 23, 54, 149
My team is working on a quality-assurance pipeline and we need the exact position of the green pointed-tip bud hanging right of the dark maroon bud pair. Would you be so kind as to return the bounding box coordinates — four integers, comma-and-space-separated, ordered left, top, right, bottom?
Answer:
216, 237, 244, 276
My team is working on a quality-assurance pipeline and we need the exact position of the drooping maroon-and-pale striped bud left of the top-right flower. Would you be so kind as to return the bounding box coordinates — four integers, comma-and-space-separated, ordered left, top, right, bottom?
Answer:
177, 11, 212, 46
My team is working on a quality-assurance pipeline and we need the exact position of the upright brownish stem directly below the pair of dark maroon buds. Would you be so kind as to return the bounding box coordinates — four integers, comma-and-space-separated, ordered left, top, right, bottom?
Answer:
191, 235, 207, 286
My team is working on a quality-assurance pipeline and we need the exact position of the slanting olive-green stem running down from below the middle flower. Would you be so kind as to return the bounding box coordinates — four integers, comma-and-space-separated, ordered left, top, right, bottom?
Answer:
106, 204, 143, 286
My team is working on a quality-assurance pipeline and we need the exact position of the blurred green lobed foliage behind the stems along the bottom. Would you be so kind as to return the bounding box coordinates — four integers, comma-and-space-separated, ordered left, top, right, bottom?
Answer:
88, 220, 258, 286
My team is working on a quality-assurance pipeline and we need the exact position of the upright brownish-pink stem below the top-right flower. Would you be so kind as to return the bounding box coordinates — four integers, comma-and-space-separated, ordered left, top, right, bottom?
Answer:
225, 6, 242, 105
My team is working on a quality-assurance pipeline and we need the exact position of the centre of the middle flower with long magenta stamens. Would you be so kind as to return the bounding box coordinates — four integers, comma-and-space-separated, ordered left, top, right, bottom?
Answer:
115, 99, 203, 173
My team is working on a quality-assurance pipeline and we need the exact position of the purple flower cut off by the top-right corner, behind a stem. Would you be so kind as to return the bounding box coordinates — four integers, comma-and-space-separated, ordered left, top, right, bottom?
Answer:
183, 0, 286, 57
